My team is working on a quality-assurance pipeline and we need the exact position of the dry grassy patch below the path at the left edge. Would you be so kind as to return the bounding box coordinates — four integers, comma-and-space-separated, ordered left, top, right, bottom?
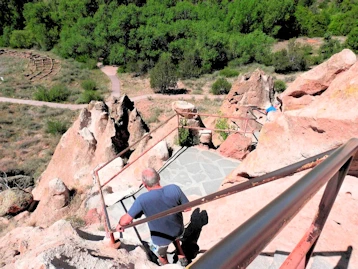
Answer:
0, 103, 79, 179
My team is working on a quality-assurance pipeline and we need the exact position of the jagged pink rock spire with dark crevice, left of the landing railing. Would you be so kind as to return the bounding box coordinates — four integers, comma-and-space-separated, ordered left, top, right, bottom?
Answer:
31, 95, 148, 226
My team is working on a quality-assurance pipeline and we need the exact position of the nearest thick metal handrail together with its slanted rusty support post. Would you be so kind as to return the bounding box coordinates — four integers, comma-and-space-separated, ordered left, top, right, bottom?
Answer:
189, 138, 358, 269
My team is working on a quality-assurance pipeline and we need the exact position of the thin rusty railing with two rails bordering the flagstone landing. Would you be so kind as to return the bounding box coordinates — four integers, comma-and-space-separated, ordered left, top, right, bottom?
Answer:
93, 111, 260, 245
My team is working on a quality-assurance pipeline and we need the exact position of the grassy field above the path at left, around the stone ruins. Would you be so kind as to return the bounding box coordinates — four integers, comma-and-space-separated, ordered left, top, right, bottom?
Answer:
0, 48, 110, 103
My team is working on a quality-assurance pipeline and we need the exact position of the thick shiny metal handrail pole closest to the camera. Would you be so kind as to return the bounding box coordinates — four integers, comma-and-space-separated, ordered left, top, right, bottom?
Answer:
190, 139, 358, 269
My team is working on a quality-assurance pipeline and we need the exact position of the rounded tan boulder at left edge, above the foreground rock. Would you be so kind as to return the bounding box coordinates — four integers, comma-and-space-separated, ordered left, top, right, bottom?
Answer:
0, 188, 33, 217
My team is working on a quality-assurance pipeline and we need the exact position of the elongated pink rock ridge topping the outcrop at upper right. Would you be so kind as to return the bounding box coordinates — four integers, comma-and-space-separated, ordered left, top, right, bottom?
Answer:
279, 49, 357, 111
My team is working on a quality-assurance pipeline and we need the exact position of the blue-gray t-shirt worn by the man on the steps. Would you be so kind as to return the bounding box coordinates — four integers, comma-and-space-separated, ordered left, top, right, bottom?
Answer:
128, 184, 189, 246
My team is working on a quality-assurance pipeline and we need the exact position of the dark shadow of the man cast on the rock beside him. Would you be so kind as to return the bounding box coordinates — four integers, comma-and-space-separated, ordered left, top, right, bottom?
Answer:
181, 208, 209, 262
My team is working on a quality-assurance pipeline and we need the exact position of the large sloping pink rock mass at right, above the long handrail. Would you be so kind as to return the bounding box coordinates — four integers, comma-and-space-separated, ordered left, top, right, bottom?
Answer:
224, 50, 358, 181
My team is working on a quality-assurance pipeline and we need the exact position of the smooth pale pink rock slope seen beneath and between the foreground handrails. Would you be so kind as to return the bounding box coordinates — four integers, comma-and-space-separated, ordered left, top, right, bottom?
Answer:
198, 172, 358, 268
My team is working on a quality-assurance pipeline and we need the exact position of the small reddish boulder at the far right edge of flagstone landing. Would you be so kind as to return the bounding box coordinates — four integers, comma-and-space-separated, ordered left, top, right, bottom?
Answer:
218, 133, 252, 160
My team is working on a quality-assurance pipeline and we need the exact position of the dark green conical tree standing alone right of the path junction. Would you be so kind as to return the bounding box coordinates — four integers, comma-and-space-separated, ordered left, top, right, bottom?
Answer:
150, 53, 178, 93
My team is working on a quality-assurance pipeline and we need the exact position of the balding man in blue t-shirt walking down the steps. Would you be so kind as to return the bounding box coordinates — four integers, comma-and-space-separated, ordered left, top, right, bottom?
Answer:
116, 168, 190, 266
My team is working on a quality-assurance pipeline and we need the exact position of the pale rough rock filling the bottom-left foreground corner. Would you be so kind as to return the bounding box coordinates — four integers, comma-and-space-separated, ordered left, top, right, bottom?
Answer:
0, 220, 178, 269
